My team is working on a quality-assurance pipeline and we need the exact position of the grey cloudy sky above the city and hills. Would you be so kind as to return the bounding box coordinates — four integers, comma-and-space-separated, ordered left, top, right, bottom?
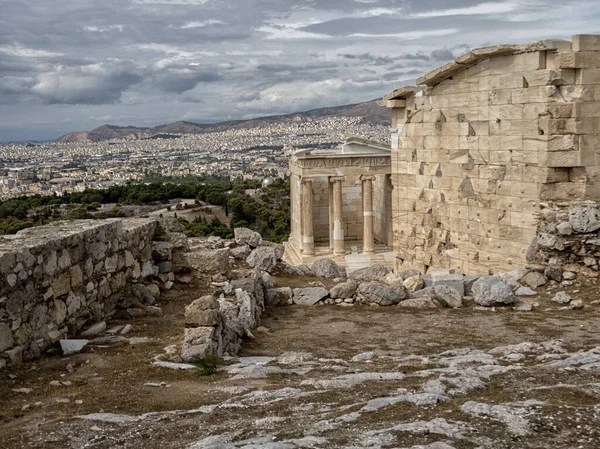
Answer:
0, 0, 600, 141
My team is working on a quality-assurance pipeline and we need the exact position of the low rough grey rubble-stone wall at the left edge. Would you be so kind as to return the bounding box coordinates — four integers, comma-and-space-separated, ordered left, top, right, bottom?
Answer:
0, 218, 173, 364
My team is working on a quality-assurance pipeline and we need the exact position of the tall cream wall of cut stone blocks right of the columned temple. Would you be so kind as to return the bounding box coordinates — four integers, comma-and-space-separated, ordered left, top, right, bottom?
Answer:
392, 36, 600, 273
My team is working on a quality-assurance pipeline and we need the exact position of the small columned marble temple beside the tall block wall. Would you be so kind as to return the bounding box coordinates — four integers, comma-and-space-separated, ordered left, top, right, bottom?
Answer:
286, 138, 393, 269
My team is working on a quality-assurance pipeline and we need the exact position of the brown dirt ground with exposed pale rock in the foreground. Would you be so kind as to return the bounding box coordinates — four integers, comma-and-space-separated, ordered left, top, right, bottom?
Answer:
0, 278, 600, 449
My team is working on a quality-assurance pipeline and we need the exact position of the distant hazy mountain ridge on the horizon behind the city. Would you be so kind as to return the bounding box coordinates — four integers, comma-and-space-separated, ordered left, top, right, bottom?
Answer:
57, 100, 390, 142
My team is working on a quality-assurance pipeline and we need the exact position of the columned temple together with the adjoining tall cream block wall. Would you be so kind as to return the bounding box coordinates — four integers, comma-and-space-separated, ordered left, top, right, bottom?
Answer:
287, 35, 600, 274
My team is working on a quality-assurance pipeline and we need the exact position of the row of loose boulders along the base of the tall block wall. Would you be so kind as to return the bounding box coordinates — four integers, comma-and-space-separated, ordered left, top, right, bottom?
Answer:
276, 259, 589, 311
